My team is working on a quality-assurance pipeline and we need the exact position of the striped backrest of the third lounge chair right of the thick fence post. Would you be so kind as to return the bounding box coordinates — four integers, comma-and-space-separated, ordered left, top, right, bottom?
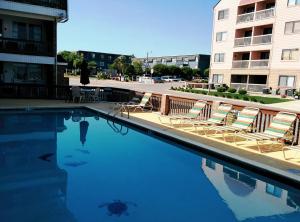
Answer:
232, 107, 259, 129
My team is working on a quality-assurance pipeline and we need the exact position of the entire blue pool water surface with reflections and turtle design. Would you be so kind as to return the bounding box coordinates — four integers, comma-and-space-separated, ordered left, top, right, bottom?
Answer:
0, 110, 300, 222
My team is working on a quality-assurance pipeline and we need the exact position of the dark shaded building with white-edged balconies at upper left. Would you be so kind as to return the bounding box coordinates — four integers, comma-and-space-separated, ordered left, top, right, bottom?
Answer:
0, 0, 68, 96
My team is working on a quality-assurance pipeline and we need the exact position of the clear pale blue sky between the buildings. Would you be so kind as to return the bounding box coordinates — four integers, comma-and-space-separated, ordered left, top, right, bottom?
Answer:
58, 0, 217, 57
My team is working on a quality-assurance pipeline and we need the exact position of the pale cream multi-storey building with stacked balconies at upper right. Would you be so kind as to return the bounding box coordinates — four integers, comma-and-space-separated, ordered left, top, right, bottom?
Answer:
210, 0, 300, 92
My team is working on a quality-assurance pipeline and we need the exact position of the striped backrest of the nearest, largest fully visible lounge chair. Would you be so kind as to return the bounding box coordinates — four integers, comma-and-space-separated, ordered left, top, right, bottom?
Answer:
265, 113, 297, 138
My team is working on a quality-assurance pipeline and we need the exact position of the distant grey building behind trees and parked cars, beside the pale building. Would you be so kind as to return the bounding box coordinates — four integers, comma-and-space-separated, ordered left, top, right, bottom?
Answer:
138, 54, 210, 70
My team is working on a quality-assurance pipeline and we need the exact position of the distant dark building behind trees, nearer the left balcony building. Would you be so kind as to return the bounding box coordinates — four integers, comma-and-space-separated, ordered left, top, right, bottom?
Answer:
77, 51, 132, 70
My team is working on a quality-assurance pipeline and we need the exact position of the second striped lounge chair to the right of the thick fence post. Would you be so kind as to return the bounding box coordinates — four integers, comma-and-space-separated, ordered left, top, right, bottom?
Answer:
184, 104, 232, 132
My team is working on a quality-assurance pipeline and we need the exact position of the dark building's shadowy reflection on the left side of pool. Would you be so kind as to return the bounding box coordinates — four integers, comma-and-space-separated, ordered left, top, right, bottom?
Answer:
0, 109, 76, 222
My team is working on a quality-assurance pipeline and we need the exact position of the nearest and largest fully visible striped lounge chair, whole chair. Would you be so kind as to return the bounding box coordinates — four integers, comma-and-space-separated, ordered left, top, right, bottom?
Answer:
236, 112, 297, 153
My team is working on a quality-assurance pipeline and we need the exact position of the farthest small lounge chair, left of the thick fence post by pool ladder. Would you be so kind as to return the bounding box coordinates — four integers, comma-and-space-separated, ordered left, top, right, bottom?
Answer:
119, 93, 153, 114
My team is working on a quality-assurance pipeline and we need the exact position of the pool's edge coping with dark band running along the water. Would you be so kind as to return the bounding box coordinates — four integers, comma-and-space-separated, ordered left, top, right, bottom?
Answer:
0, 105, 300, 188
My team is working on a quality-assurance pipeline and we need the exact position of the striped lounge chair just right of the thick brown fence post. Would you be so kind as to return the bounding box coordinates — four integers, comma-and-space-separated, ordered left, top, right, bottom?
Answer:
158, 100, 207, 126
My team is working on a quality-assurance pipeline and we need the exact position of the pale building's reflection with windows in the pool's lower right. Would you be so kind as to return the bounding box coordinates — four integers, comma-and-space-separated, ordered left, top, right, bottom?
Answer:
202, 159, 300, 221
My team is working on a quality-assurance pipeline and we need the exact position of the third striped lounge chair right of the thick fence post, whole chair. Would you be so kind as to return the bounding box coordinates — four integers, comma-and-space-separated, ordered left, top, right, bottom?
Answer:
205, 107, 260, 141
